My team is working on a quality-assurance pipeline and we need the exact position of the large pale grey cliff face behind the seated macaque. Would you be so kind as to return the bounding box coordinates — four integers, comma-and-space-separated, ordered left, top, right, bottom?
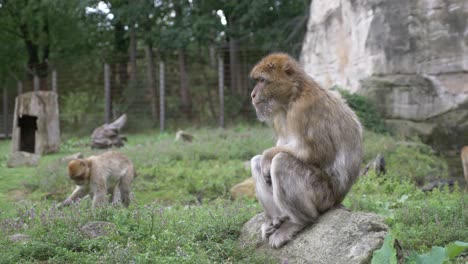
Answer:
301, 0, 468, 148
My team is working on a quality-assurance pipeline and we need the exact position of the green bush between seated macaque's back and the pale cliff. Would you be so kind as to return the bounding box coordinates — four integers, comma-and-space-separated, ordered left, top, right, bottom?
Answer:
332, 87, 387, 133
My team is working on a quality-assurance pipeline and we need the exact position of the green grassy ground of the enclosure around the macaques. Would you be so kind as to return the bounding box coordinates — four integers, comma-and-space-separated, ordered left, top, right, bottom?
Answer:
0, 126, 468, 263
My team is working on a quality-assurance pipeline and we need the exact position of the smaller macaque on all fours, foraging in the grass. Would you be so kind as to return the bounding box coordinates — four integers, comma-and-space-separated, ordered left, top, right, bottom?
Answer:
59, 151, 135, 208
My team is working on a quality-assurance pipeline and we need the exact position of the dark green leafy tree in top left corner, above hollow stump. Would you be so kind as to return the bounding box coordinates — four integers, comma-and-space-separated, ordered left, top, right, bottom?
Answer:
0, 0, 90, 87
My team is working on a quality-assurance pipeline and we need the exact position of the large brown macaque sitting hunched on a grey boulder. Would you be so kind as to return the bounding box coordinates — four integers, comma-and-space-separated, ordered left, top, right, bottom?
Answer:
250, 53, 362, 248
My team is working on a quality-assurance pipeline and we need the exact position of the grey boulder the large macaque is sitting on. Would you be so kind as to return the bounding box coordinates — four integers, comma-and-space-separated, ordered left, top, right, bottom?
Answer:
239, 209, 388, 264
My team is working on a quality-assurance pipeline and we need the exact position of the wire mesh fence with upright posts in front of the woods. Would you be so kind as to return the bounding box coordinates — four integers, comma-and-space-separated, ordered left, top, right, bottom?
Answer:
0, 48, 272, 137
